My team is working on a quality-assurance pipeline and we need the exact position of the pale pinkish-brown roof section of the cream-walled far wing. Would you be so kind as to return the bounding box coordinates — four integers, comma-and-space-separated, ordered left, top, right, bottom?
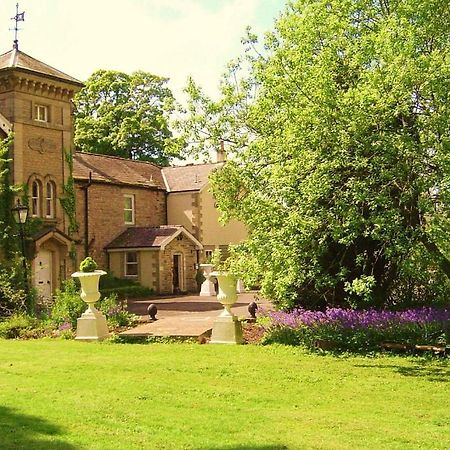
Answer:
162, 163, 223, 192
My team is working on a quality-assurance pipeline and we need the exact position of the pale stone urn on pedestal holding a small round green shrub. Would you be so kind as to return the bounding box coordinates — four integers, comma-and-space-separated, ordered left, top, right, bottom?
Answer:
72, 270, 109, 341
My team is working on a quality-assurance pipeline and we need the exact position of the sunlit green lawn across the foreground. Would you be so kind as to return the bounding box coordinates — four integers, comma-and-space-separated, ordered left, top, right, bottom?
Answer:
0, 340, 450, 450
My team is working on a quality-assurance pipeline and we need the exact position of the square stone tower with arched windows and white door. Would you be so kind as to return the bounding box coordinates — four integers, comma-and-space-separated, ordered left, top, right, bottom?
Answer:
0, 44, 83, 297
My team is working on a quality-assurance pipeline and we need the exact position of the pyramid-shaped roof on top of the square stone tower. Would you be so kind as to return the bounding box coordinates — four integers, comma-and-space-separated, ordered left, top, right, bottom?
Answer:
0, 48, 83, 86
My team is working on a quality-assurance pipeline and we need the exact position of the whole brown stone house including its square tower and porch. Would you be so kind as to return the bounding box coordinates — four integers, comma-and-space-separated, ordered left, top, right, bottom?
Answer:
0, 45, 246, 297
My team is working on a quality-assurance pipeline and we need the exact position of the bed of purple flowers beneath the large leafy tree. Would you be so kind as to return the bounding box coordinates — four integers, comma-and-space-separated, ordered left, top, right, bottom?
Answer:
260, 307, 450, 351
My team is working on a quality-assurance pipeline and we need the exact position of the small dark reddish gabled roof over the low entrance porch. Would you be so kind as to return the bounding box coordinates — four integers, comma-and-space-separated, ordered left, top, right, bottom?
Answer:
105, 225, 198, 250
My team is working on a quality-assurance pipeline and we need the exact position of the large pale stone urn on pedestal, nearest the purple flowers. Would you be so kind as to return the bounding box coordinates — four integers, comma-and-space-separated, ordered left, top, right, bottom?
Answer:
210, 272, 244, 344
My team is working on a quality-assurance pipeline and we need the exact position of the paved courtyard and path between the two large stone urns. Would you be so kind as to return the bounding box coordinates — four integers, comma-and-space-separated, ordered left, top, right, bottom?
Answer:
121, 292, 269, 337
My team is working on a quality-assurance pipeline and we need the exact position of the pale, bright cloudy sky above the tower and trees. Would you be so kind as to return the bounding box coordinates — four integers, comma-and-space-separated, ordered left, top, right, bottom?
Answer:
0, 0, 286, 101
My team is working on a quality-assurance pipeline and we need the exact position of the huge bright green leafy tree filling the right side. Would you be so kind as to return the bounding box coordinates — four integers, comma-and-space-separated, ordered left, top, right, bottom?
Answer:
179, 0, 450, 308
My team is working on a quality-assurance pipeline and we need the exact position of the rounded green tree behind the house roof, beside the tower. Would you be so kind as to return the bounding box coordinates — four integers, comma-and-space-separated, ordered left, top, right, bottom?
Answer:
74, 70, 178, 165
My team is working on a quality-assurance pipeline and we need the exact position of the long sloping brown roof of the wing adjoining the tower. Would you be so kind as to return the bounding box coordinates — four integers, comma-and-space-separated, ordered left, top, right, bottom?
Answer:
73, 152, 165, 189
